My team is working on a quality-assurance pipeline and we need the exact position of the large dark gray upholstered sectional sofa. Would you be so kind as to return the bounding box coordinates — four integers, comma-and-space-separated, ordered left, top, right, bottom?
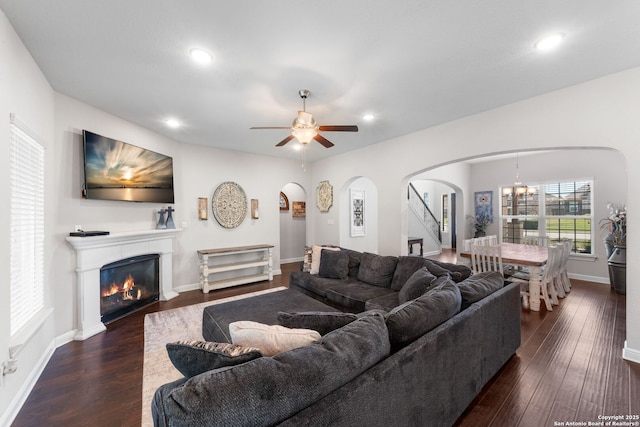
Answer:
152, 251, 520, 427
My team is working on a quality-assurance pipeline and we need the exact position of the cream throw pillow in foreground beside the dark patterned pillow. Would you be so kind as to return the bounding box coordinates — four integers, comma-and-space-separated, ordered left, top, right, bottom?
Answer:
229, 320, 321, 356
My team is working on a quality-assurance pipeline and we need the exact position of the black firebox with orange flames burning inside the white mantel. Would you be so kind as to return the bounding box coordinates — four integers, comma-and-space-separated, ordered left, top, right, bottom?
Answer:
100, 254, 160, 323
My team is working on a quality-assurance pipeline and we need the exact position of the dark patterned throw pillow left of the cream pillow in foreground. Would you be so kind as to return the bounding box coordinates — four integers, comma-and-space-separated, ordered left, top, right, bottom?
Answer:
167, 340, 262, 378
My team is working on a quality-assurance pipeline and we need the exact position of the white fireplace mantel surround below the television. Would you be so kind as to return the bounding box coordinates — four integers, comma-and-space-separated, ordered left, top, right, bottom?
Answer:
66, 229, 181, 340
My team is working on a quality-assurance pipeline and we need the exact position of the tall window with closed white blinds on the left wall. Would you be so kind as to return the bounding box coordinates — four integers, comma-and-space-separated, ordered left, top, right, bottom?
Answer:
9, 116, 44, 336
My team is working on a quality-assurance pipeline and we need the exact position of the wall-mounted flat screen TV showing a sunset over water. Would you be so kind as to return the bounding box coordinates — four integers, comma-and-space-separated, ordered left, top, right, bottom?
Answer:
83, 130, 174, 203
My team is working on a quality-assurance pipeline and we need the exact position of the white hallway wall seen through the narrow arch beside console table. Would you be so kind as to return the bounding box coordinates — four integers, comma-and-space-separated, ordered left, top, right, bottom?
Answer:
279, 182, 311, 262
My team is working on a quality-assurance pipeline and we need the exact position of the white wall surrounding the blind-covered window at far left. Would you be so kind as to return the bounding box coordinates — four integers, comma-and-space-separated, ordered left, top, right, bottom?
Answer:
0, 11, 58, 425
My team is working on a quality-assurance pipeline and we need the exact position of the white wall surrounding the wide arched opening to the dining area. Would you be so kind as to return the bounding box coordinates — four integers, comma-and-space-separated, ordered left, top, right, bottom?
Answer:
310, 68, 640, 361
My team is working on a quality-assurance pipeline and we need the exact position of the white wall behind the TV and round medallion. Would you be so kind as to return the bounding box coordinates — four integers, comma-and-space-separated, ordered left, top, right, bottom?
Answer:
54, 94, 308, 335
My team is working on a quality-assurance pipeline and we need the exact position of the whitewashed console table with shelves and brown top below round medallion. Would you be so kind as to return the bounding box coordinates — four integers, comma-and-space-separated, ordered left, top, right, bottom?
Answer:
198, 245, 273, 293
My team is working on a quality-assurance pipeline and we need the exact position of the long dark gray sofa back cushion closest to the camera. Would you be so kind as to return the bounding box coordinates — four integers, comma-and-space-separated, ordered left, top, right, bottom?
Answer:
152, 314, 390, 426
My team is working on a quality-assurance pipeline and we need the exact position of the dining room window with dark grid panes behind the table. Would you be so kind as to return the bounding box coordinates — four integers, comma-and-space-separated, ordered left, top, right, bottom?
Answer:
500, 180, 593, 254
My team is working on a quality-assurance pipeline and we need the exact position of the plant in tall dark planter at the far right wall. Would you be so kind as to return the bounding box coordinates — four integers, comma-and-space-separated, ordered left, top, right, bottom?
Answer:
600, 203, 627, 294
